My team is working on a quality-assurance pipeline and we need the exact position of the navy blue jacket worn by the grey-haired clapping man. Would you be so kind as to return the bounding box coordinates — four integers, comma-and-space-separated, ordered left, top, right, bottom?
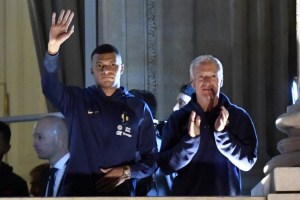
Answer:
157, 93, 257, 196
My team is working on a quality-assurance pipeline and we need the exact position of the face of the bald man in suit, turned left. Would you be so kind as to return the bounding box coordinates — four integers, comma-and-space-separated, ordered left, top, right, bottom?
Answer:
33, 122, 59, 160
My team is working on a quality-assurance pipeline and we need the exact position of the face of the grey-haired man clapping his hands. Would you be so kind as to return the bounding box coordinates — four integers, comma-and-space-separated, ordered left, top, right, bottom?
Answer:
192, 62, 223, 99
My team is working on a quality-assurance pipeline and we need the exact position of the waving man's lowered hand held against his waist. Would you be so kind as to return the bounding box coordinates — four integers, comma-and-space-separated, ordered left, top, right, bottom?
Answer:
96, 166, 130, 193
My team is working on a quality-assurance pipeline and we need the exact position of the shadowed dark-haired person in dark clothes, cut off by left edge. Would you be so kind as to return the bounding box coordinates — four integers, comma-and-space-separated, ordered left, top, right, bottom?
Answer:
0, 121, 29, 197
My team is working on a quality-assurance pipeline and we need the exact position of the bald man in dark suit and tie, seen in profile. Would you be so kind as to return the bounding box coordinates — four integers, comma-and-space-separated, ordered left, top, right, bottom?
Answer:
33, 115, 70, 197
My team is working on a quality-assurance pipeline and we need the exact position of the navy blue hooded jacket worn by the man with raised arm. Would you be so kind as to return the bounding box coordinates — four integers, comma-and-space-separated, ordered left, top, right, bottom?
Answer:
42, 53, 157, 196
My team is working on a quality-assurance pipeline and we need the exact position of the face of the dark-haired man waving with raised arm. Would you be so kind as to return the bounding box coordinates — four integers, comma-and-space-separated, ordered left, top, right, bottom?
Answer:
91, 53, 124, 89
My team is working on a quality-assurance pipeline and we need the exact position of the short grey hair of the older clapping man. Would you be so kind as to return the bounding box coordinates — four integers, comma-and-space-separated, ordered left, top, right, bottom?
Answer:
190, 55, 223, 80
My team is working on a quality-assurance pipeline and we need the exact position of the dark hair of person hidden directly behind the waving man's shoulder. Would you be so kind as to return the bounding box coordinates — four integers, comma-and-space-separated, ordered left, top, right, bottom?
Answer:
129, 89, 157, 118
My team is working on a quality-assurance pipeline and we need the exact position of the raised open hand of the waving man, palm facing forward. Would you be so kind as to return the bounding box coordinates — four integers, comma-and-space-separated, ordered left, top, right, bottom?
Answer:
48, 10, 74, 55
